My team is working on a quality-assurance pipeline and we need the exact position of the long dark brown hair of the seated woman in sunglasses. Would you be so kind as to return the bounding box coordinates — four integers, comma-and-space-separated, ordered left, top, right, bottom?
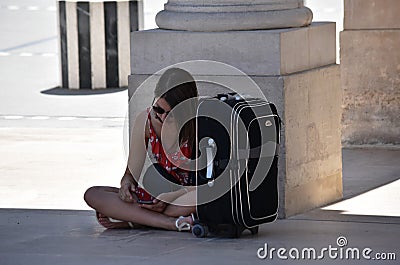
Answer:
154, 68, 198, 151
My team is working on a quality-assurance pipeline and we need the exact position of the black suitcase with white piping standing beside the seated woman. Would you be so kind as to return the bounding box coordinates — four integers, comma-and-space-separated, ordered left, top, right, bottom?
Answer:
192, 93, 280, 237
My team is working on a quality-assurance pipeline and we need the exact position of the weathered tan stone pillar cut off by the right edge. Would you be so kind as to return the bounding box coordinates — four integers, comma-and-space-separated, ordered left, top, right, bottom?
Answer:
340, 0, 400, 145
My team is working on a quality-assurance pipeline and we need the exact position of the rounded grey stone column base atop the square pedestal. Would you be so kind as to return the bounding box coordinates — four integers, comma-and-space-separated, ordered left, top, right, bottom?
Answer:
156, 0, 312, 31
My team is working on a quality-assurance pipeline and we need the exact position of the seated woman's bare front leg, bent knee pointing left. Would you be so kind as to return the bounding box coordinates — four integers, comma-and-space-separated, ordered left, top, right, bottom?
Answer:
85, 187, 192, 230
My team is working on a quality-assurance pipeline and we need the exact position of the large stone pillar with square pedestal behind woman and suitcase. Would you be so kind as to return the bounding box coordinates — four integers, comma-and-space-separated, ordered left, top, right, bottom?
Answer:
129, 0, 342, 218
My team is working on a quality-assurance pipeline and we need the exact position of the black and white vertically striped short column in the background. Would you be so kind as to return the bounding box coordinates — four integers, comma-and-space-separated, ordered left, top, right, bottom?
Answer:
57, 0, 143, 89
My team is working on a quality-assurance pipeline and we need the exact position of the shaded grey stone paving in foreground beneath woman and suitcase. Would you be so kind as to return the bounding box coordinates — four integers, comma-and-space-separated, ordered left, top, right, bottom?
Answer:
0, 209, 400, 265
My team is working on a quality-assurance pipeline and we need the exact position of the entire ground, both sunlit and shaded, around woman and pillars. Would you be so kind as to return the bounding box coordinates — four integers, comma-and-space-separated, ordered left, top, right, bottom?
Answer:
0, 0, 400, 265
